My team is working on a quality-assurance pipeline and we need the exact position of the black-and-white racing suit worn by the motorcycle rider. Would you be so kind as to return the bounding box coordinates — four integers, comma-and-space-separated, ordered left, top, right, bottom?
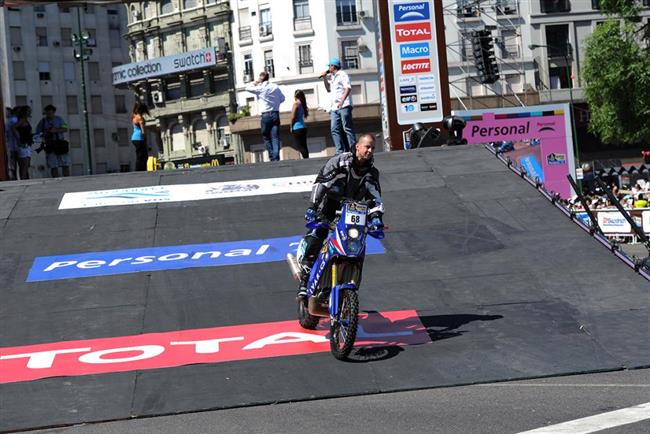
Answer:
298, 152, 384, 276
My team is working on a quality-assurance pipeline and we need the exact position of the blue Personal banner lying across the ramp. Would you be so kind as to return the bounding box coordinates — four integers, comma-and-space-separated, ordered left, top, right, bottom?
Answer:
27, 235, 385, 282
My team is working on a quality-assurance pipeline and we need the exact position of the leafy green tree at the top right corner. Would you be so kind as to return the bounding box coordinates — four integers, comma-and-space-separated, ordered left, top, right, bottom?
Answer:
583, 0, 650, 146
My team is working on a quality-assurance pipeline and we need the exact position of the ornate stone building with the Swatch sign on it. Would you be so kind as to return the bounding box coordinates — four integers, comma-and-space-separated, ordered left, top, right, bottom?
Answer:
119, 0, 239, 167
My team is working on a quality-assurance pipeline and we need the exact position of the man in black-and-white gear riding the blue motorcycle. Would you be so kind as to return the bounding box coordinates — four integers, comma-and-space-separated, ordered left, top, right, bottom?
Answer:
297, 134, 384, 298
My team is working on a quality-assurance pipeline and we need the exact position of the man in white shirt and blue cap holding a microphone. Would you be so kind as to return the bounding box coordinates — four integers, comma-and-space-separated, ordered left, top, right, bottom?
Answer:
320, 57, 357, 154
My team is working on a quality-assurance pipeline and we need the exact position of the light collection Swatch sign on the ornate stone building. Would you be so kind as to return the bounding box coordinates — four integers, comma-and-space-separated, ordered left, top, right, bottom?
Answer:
112, 47, 217, 85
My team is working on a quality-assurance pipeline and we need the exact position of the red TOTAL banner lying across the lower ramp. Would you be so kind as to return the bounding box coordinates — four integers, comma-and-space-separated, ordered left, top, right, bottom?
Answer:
0, 310, 430, 384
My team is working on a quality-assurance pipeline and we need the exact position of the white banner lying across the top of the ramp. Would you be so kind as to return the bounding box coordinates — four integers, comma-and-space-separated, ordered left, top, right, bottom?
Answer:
59, 175, 316, 209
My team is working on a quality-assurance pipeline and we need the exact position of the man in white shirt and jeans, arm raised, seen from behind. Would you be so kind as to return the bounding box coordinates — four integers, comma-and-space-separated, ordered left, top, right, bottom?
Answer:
246, 71, 284, 161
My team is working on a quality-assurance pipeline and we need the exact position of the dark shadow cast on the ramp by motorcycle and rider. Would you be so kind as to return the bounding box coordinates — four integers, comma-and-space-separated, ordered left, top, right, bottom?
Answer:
348, 311, 503, 363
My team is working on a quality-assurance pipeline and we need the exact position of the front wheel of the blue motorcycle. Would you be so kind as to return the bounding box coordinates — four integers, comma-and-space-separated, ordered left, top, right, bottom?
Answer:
330, 289, 359, 360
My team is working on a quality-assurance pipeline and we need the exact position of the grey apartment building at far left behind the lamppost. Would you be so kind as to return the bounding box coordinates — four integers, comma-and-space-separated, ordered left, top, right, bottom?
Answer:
0, 4, 135, 178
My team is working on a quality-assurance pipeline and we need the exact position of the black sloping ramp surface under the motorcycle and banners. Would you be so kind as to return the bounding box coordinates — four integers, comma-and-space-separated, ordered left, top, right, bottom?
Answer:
0, 146, 650, 430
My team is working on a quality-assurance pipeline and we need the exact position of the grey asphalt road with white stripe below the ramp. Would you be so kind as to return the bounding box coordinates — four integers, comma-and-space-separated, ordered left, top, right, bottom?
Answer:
38, 369, 650, 434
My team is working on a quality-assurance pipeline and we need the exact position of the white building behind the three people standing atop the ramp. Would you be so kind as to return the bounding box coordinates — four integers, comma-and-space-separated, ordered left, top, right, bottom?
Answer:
231, 0, 381, 163
